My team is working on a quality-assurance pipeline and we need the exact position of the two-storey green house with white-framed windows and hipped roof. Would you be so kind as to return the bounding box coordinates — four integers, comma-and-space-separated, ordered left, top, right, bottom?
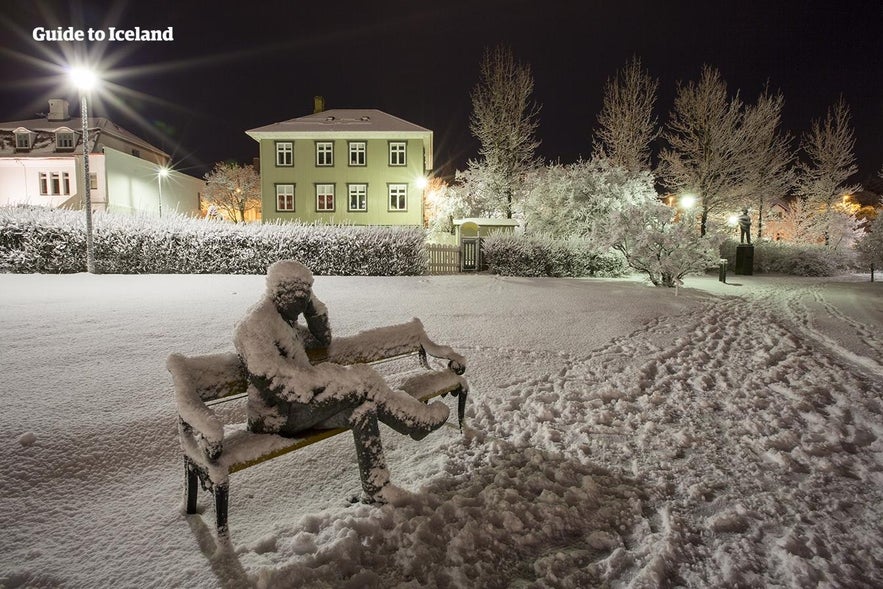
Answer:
246, 109, 432, 226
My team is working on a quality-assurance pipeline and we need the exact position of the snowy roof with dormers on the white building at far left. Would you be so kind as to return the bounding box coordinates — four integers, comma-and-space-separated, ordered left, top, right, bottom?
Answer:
0, 117, 169, 158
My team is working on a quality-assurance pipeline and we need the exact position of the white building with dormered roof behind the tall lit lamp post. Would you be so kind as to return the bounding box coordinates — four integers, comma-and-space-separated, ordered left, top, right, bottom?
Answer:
0, 99, 205, 215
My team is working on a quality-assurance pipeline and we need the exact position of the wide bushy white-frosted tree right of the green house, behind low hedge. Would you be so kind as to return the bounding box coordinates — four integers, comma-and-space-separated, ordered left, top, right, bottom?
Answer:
524, 156, 657, 237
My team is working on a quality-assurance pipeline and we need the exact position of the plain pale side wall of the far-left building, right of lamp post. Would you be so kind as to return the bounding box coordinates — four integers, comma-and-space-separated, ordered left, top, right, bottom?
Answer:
102, 147, 205, 216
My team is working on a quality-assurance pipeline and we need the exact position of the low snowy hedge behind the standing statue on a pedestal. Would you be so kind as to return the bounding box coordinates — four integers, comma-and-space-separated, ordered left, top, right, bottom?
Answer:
721, 240, 855, 276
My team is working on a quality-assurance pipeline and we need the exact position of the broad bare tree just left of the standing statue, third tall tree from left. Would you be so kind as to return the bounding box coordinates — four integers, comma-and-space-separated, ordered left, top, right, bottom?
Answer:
659, 66, 751, 235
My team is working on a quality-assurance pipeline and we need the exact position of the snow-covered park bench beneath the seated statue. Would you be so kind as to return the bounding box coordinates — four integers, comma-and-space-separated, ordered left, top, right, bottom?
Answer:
166, 321, 468, 536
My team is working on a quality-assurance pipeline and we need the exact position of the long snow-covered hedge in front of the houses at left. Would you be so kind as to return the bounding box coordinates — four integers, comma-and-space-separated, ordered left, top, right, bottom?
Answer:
0, 207, 427, 276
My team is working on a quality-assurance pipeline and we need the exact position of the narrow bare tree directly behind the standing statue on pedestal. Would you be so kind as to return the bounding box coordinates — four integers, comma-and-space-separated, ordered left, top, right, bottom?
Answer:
742, 90, 796, 241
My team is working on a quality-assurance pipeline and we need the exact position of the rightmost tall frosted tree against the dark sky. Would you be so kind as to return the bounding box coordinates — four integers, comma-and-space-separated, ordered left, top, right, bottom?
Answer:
797, 97, 861, 247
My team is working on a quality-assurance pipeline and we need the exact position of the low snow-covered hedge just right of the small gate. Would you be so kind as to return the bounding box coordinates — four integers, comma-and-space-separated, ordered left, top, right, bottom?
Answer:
482, 233, 630, 277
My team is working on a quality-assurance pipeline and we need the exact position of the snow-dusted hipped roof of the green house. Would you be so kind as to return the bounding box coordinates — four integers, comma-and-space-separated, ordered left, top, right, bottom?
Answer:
246, 108, 432, 139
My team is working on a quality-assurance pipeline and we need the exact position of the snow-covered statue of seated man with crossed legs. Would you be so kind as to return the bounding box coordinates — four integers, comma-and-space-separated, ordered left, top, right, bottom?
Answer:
233, 260, 452, 502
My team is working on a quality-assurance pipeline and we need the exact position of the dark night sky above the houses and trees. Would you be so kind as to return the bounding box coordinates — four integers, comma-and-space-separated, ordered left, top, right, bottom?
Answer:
0, 0, 883, 187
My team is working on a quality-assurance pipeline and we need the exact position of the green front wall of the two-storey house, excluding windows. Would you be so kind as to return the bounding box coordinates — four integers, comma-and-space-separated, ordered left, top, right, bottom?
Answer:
260, 136, 425, 226
